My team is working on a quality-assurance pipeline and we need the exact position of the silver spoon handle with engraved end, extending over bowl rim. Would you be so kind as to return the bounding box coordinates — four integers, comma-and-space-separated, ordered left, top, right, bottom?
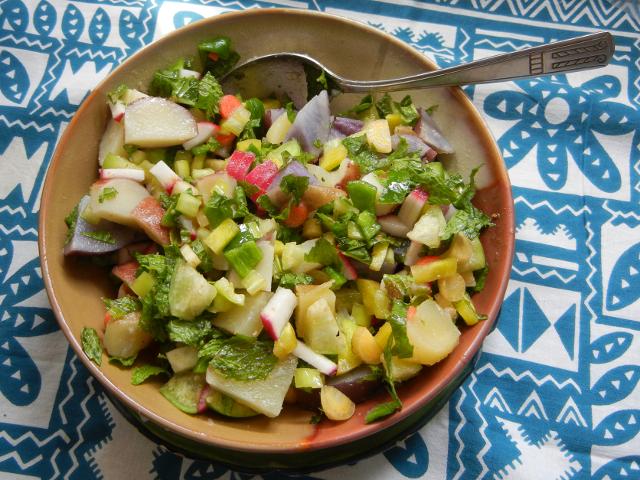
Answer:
340, 32, 615, 93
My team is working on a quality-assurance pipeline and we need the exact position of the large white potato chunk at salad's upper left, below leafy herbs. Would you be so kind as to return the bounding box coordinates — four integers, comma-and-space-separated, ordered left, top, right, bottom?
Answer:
124, 97, 198, 147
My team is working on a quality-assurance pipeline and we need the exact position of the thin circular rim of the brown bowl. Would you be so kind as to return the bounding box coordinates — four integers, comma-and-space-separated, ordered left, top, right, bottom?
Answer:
38, 8, 515, 455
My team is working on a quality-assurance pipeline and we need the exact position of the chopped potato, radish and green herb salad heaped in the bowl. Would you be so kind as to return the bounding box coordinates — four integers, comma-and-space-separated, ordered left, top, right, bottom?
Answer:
64, 37, 491, 423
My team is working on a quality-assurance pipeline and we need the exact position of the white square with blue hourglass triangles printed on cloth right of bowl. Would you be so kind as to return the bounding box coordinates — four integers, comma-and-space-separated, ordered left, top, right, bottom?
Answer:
483, 280, 580, 372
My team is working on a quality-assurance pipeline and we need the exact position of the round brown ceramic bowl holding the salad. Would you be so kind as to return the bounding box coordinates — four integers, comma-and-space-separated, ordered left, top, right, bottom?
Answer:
39, 9, 514, 463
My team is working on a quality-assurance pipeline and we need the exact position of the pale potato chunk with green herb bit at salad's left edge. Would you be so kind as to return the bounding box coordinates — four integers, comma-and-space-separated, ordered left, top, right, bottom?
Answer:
89, 178, 149, 228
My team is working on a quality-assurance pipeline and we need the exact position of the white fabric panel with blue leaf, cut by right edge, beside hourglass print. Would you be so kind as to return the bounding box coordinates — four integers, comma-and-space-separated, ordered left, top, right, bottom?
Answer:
600, 220, 640, 324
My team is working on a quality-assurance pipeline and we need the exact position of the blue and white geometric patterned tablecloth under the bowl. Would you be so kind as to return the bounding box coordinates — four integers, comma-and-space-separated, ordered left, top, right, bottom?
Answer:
0, 0, 640, 480
